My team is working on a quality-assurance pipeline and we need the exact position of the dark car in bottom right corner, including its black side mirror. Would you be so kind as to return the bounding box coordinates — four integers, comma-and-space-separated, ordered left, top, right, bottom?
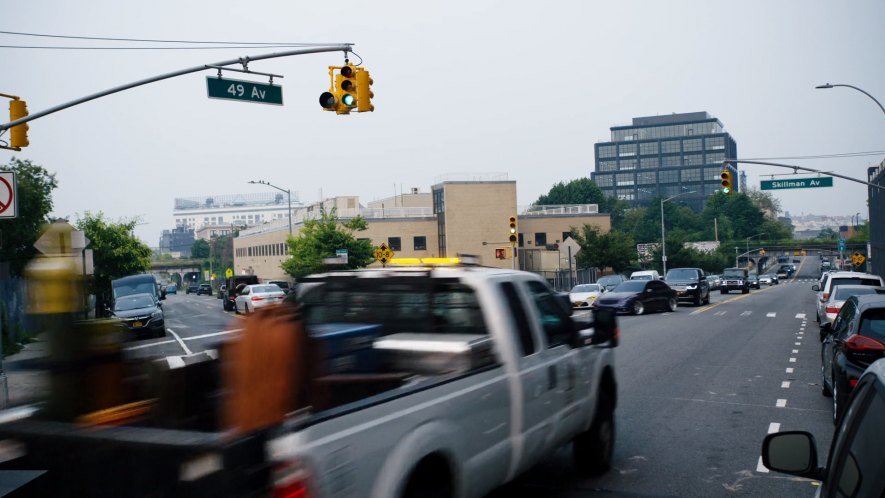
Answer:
762, 360, 885, 498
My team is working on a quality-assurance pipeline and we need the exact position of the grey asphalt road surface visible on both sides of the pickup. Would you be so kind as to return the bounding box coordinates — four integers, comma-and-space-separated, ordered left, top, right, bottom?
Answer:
128, 257, 833, 498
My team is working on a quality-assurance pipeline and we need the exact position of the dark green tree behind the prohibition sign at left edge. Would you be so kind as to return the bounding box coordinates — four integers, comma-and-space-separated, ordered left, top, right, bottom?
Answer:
0, 157, 58, 275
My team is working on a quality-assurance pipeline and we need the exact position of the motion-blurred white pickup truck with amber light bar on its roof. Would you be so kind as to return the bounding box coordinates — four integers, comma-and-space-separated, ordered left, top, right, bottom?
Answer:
0, 266, 618, 498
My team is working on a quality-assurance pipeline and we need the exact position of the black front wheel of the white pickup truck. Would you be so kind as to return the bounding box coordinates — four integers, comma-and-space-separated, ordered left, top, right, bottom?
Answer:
572, 391, 615, 475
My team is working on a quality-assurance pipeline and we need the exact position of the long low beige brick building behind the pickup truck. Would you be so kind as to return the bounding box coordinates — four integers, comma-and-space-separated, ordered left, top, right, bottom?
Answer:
234, 175, 611, 281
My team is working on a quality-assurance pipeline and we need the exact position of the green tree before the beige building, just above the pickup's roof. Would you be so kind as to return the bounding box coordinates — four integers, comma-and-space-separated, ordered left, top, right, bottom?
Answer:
281, 208, 375, 279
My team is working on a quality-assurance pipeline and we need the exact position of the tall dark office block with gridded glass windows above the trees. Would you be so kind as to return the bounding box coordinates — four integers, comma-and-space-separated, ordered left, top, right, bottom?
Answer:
592, 112, 742, 211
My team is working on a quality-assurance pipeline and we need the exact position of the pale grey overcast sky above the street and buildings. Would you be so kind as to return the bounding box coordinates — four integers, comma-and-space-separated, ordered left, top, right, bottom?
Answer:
0, 0, 885, 247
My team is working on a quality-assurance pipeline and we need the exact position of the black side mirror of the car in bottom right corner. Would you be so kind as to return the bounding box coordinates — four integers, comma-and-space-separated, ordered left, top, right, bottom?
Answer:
762, 431, 824, 480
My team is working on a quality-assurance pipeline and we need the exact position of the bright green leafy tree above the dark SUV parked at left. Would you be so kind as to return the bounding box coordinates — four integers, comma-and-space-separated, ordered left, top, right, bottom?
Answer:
74, 211, 151, 310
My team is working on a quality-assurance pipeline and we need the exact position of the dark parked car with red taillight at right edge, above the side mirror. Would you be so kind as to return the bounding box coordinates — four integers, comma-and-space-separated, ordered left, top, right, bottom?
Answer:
821, 294, 885, 423
